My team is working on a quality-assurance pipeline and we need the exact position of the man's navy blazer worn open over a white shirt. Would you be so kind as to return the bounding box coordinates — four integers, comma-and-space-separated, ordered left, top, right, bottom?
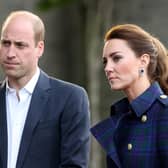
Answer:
0, 72, 90, 168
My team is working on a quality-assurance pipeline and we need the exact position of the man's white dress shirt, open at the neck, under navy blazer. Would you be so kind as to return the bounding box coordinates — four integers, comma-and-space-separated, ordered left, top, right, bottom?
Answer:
6, 68, 40, 168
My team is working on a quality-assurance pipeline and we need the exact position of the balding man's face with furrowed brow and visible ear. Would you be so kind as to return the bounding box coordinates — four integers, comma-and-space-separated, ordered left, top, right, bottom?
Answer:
0, 16, 43, 83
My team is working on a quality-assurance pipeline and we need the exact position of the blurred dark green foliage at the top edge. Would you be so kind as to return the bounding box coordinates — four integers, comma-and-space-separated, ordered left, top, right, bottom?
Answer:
37, 0, 77, 11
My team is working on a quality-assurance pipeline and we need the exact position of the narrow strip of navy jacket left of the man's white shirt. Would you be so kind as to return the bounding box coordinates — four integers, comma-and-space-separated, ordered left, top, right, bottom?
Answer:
0, 82, 8, 167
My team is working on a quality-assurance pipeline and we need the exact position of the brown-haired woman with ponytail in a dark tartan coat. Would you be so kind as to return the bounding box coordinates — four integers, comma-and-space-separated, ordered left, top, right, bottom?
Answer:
91, 24, 168, 168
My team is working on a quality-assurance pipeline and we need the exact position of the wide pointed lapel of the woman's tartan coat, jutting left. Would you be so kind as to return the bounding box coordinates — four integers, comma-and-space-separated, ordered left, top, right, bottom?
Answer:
91, 118, 121, 168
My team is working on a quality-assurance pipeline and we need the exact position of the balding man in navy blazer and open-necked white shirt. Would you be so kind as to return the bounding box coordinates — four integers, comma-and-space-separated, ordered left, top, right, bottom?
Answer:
0, 11, 89, 168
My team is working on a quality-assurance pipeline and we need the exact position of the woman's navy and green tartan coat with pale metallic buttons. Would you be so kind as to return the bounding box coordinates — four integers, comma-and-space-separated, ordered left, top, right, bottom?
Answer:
91, 82, 168, 168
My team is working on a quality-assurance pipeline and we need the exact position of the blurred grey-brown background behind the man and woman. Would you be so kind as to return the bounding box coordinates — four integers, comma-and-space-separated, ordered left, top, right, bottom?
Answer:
0, 0, 168, 168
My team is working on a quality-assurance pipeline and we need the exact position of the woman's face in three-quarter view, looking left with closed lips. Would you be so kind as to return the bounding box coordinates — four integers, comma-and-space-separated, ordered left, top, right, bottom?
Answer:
103, 39, 142, 90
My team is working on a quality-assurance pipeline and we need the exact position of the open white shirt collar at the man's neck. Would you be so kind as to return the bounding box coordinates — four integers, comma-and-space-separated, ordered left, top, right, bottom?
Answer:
6, 68, 40, 94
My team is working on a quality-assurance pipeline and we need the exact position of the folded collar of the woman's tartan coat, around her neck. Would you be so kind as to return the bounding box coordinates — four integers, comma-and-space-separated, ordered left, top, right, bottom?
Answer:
111, 82, 164, 117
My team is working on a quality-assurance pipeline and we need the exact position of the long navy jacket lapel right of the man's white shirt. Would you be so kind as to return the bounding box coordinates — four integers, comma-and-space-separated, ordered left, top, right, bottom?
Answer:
16, 72, 49, 168
